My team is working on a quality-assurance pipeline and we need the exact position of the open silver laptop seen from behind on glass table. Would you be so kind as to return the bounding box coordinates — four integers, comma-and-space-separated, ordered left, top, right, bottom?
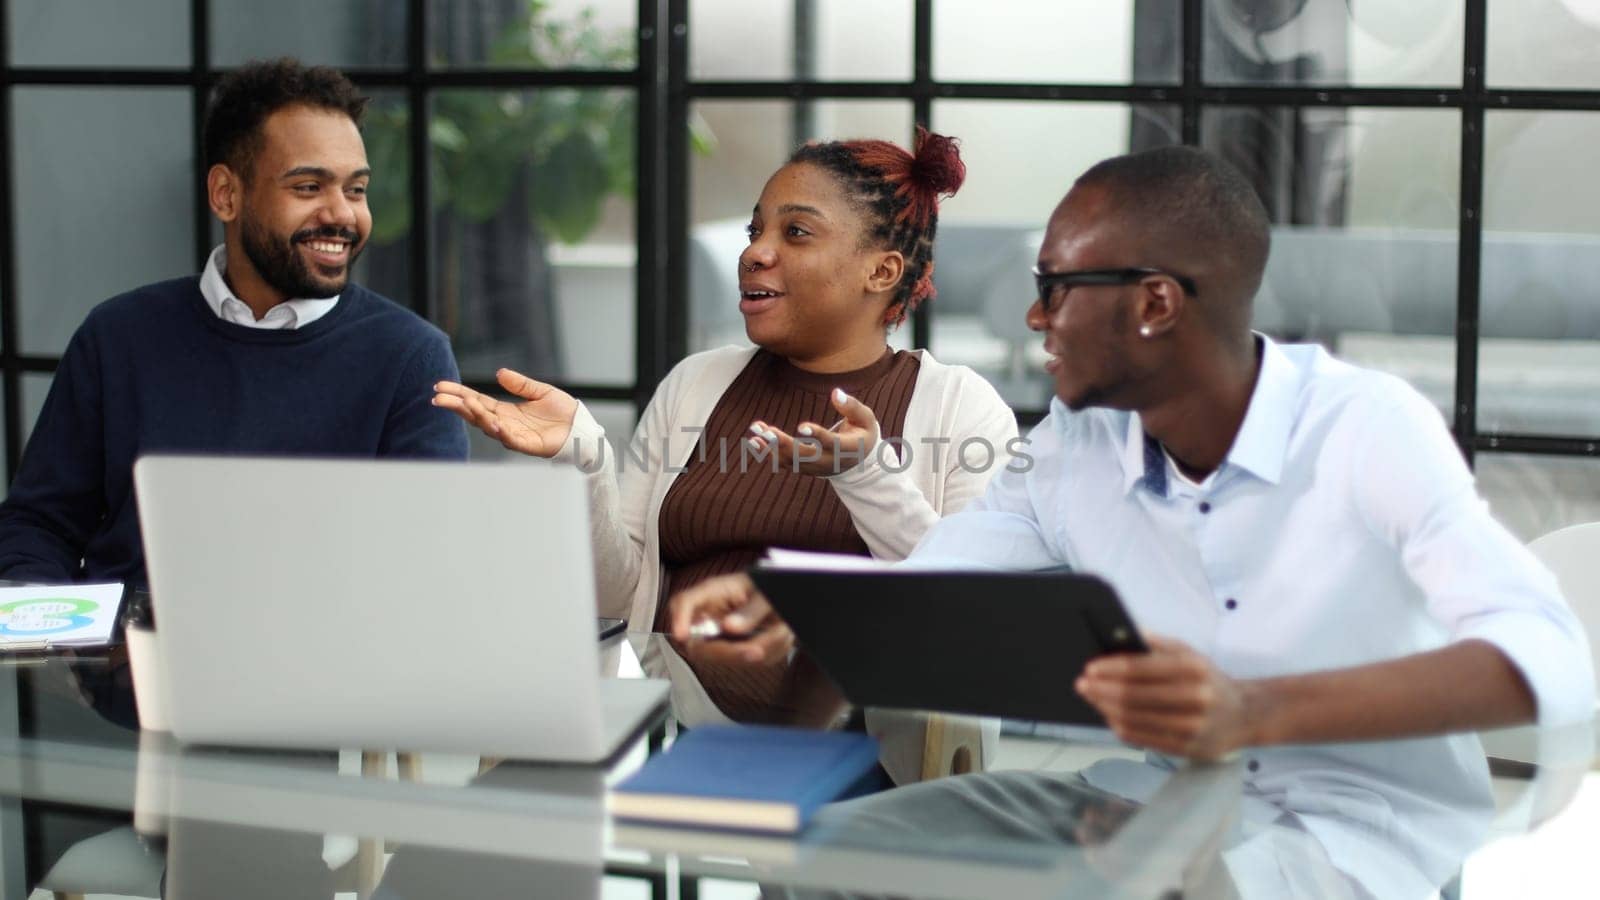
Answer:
133, 456, 666, 762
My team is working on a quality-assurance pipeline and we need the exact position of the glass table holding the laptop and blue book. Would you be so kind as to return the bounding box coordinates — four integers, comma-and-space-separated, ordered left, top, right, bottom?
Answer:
0, 634, 1600, 900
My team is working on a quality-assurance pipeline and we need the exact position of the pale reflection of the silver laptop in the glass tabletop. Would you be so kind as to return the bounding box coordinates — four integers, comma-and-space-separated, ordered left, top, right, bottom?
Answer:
151, 740, 605, 900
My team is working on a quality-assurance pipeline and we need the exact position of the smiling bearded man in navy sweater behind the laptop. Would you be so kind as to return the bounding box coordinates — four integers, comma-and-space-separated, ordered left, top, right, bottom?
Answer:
0, 59, 467, 583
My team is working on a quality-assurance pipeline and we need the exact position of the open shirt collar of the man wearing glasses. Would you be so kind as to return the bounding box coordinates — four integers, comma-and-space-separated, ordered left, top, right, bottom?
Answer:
1122, 333, 1299, 496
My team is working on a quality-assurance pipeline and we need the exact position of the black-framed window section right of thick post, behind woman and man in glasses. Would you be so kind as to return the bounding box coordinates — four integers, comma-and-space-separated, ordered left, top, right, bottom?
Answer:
672, 0, 1600, 538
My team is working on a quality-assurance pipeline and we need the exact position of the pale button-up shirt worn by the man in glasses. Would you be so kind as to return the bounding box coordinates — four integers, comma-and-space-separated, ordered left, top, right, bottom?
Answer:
912, 338, 1595, 897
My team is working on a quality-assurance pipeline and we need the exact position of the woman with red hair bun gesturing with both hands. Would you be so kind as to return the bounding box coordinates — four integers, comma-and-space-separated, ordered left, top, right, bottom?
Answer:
435, 128, 1016, 781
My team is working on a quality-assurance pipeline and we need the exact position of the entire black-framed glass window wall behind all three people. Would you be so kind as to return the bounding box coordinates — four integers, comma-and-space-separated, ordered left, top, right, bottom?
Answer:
0, 0, 1600, 536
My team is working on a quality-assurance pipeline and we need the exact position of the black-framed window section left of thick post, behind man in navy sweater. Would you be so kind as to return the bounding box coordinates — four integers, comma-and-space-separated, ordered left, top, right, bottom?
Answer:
0, 0, 652, 464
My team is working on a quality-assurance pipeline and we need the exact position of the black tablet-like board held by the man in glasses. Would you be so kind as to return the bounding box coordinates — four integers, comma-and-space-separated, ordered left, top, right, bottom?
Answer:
750, 567, 1146, 725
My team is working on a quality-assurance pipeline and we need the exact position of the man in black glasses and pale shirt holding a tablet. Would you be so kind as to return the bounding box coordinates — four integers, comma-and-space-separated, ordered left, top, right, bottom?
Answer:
682, 147, 1595, 897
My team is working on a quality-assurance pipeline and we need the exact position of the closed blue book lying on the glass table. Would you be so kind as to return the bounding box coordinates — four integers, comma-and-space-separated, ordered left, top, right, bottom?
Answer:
611, 725, 878, 834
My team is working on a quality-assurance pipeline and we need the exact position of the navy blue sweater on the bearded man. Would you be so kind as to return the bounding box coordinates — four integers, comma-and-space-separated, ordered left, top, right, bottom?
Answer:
0, 277, 467, 585
